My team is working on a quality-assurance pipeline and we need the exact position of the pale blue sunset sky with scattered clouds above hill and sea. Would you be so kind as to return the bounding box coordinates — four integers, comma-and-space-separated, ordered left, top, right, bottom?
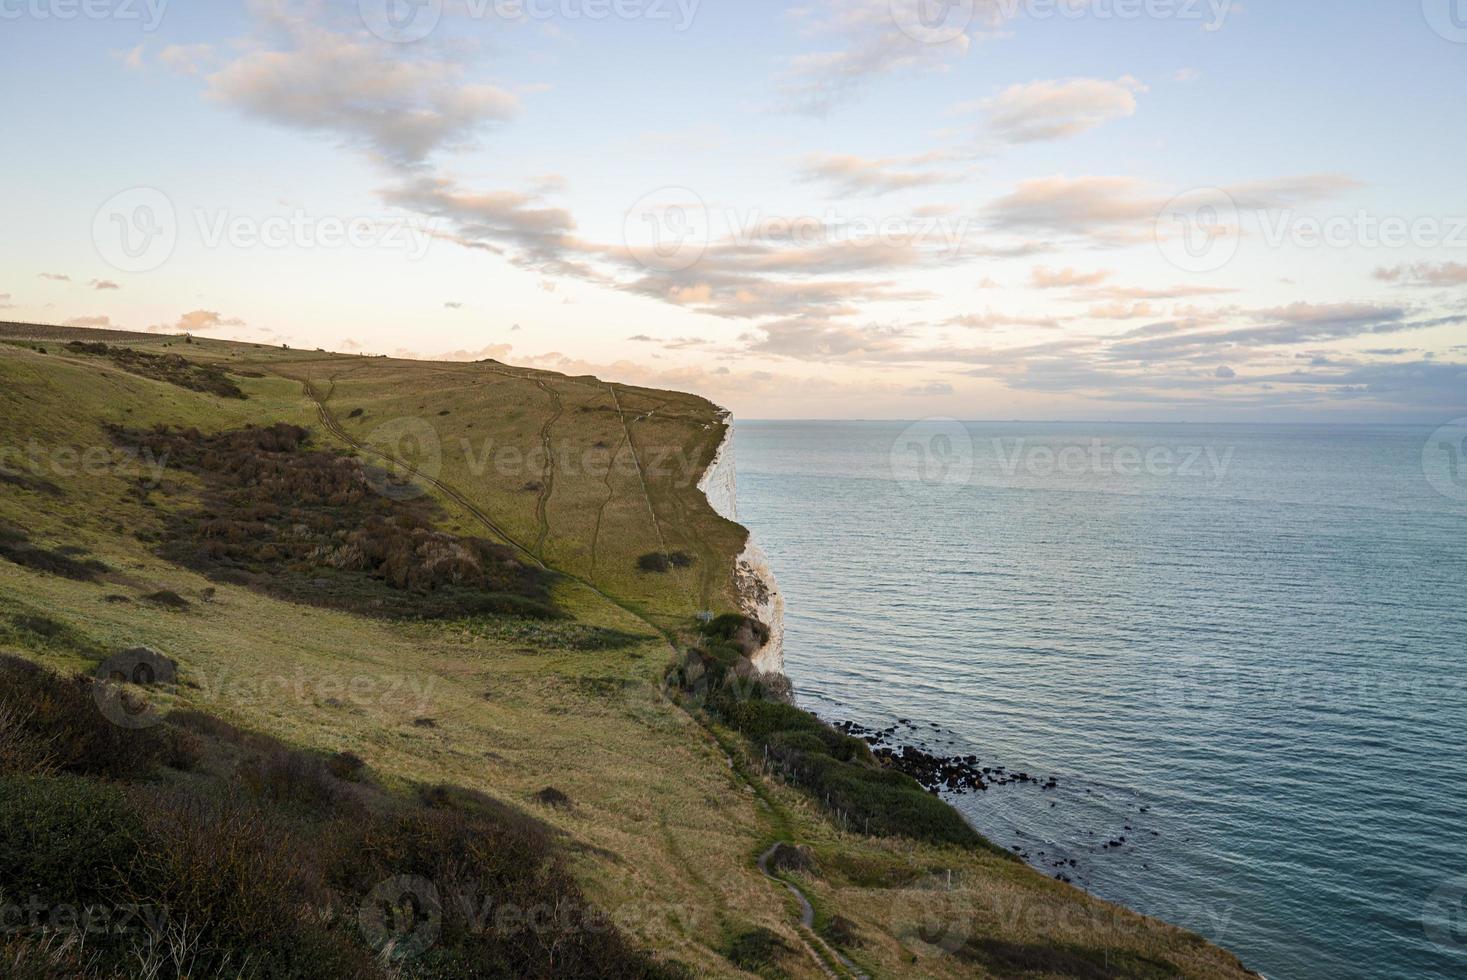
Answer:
0, 0, 1467, 424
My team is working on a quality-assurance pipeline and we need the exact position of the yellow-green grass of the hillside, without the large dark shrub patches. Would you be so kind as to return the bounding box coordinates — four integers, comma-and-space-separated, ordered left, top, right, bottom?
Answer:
0, 326, 1245, 979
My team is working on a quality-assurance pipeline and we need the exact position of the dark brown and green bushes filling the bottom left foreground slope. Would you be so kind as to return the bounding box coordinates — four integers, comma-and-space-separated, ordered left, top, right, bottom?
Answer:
0, 659, 688, 980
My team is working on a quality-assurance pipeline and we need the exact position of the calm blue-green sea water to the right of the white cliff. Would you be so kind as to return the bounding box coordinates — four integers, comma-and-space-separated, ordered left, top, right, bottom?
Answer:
735, 421, 1467, 980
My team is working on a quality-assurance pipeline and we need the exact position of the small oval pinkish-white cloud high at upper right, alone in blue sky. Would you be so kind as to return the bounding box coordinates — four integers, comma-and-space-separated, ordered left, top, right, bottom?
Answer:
978, 75, 1147, 144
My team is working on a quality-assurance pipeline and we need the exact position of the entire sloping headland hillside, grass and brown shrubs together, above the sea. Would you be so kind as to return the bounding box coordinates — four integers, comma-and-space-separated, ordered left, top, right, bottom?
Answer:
0, 326, 1245, 977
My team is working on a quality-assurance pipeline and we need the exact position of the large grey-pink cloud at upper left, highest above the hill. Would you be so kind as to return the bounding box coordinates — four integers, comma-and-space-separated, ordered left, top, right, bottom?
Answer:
199, 7, 519, 166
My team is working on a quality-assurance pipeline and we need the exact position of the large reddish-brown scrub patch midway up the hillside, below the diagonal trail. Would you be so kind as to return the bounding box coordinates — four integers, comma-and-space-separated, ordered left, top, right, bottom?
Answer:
113, 424, 560, 619
